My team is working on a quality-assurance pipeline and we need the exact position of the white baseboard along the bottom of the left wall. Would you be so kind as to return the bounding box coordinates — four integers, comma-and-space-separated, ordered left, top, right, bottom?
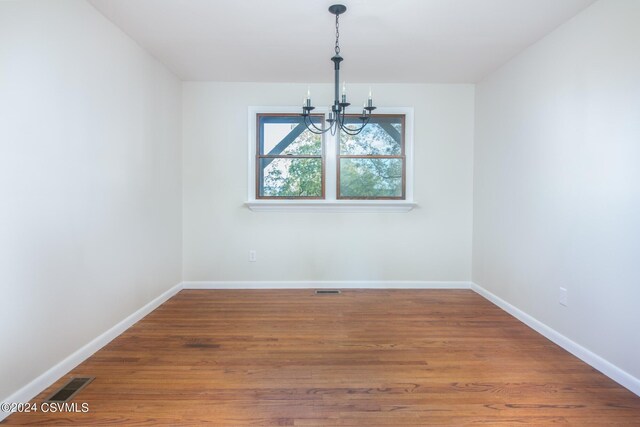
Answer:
0, 283, 182, 421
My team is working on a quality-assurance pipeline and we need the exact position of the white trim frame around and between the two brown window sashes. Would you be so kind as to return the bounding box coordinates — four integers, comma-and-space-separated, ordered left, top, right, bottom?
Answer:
245, 107, 416, 212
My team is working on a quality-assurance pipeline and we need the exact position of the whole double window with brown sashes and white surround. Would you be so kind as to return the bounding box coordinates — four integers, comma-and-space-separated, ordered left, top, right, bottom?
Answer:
247, 107, 414, 211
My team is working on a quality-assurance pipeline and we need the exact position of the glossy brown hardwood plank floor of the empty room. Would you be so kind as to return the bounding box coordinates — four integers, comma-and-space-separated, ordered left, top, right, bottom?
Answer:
4, 290, 640, 426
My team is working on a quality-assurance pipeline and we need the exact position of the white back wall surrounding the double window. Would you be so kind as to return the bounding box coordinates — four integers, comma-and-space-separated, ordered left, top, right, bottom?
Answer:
183, 83, 474, 281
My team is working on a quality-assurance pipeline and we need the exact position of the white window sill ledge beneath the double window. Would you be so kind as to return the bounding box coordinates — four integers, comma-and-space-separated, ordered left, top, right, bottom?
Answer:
245, 200, 417, 213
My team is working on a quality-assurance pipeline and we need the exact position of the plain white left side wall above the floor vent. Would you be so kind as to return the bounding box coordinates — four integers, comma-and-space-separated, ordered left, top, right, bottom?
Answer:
0, 0, 181, 400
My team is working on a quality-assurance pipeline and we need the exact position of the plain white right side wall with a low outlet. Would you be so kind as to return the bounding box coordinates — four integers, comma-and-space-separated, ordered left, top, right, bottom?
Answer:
473, 0, 640, 378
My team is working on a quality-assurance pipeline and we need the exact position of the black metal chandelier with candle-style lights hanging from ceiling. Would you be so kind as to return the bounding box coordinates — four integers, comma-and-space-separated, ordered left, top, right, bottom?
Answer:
302, 4, 376, 135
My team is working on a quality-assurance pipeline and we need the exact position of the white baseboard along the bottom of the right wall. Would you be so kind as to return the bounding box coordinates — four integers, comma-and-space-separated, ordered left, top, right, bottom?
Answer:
471, 283, 640, 396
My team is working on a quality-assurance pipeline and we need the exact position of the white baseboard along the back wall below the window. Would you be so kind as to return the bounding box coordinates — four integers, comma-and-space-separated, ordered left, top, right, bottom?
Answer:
182, 280, 471, 289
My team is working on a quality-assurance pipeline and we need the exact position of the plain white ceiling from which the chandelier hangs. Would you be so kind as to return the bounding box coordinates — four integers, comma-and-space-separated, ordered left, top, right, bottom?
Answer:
89, 0, 594, 83
